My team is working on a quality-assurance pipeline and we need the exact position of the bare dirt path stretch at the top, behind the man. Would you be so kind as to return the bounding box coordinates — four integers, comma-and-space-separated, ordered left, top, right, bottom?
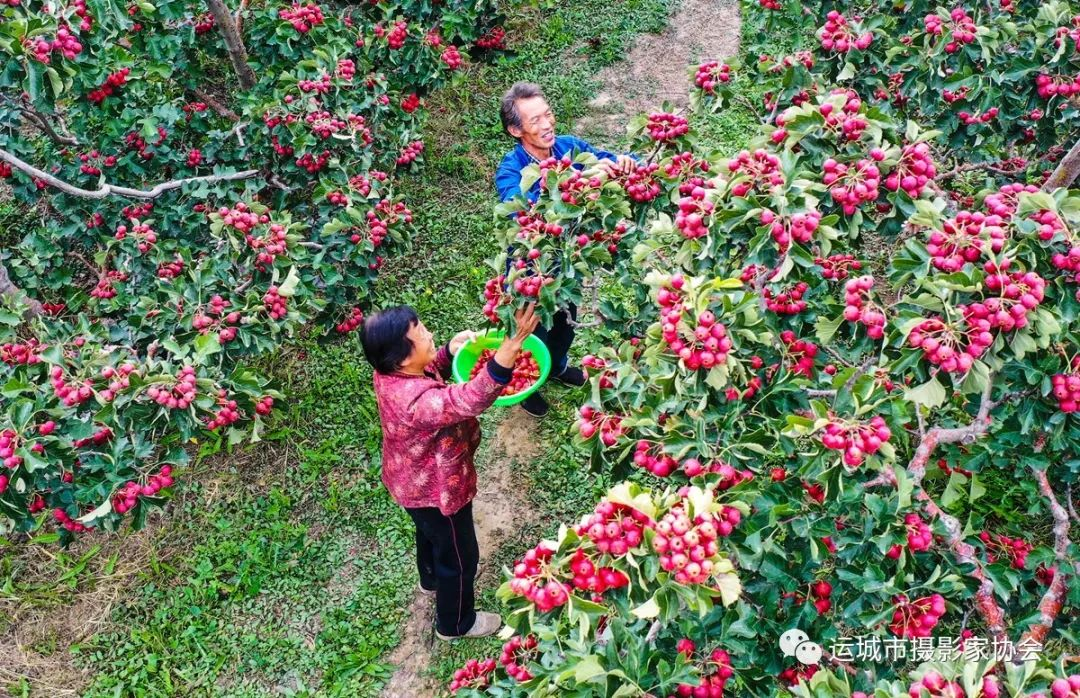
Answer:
575, 0, 741, 143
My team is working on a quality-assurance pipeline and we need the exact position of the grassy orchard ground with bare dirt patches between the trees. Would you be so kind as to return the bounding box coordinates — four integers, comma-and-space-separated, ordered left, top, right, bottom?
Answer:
0, 0, 756, 696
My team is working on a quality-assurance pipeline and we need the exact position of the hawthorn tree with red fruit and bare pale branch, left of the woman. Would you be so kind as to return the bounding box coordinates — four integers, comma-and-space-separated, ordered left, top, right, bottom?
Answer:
0, 0, 504, 538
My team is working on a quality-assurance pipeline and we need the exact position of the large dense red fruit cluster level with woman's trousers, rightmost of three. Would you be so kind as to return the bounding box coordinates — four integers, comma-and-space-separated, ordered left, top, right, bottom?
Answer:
652, 505, 741, 585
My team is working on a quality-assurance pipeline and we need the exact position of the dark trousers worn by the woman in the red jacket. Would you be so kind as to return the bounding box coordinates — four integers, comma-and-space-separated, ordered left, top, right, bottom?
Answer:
405, 502, 480, 635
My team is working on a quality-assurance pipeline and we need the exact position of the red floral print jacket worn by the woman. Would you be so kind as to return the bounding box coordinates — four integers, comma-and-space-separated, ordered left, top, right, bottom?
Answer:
375, 345, 511, 516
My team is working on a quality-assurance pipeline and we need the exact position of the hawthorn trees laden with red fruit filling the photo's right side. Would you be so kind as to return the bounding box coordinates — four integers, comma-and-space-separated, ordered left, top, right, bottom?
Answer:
454, 2, 1080, 698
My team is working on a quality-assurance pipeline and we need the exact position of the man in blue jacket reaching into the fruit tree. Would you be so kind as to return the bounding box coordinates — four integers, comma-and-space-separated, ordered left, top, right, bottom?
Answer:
495, 82, 636, 417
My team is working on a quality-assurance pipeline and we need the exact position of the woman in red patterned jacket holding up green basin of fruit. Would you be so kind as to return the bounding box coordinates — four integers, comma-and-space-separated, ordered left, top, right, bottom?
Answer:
361, 306, 538, 640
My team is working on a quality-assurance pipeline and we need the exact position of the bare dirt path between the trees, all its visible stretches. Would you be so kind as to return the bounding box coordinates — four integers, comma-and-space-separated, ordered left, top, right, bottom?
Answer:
382, 0, 740, 698
